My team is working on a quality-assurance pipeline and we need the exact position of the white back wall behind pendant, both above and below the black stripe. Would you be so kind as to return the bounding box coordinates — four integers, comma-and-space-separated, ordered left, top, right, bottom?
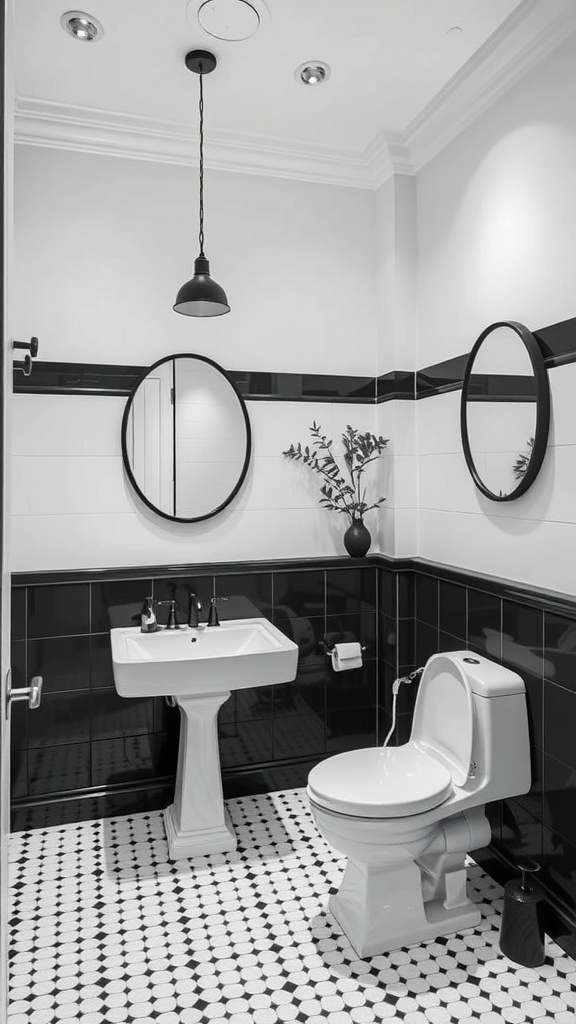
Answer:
12, 146, 377, 571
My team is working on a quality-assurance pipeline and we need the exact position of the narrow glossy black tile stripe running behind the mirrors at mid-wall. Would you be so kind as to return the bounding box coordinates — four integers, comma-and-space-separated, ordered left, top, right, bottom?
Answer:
13, 317, 576, 406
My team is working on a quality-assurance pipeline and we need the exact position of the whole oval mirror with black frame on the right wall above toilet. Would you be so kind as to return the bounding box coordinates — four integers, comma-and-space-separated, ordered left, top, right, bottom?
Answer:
460, 321, 550, 502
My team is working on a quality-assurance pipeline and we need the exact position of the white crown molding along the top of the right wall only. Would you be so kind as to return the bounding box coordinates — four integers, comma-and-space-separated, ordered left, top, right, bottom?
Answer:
403, 0, 576, 172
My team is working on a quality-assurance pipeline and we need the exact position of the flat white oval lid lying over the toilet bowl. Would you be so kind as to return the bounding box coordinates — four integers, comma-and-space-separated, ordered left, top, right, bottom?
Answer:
308, 743, 452, 818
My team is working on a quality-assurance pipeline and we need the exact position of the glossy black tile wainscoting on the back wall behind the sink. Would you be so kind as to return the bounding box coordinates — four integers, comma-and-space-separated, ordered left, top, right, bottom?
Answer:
8, 559, 381, 829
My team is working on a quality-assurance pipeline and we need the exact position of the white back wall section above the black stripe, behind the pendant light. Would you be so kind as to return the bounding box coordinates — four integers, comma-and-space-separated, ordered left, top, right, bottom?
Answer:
14, 145, 376, 375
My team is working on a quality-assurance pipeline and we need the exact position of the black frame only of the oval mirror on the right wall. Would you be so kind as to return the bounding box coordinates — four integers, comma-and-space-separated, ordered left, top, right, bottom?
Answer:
460, 321, 550, 502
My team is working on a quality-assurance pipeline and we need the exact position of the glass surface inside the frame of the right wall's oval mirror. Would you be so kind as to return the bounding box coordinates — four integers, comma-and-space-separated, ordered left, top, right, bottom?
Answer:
465, 327, 538, 498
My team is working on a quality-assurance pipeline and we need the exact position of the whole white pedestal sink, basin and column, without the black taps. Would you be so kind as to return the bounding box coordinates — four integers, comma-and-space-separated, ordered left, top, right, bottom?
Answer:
111, 618, 298, 860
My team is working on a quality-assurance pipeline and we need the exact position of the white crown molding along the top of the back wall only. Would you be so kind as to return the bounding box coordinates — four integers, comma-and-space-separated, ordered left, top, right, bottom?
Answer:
15, 96, 403, 188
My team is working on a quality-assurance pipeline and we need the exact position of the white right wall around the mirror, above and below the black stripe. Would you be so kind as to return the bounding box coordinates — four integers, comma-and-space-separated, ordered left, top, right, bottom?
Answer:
416, 37, 576, 594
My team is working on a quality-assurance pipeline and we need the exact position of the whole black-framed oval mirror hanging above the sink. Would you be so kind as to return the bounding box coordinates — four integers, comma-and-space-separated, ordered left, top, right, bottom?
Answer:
122, 354, 252, 522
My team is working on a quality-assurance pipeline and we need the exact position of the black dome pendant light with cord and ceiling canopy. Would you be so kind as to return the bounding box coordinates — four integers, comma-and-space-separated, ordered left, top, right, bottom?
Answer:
173, 50, 230, 316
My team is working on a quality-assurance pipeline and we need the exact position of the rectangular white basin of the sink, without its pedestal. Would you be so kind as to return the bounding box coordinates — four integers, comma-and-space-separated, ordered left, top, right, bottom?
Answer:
111, 618, 298, 697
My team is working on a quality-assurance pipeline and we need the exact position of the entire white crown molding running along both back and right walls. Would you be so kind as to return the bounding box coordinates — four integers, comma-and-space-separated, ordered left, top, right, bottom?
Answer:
14, 0, 576, 189
